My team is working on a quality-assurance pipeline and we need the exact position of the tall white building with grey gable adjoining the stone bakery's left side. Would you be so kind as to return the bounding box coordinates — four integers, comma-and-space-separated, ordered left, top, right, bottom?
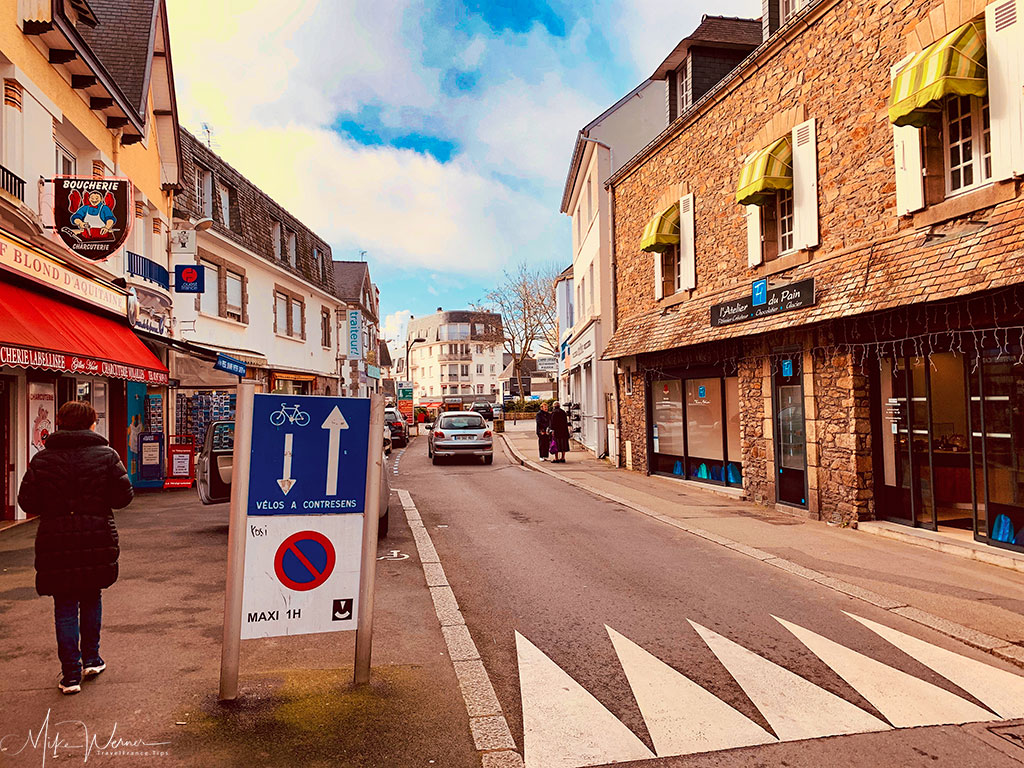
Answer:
559, 80, 666, 456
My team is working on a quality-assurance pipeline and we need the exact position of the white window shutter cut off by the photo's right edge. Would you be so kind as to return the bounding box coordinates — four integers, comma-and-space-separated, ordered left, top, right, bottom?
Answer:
985, 0, 1024, 179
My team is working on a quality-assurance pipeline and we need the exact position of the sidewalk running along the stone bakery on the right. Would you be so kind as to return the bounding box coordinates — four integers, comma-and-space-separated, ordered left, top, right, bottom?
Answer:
502, 423, 1024, 667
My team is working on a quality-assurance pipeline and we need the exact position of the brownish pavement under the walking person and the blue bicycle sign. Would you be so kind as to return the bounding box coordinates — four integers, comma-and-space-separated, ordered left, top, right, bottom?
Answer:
0, 490, 480, 768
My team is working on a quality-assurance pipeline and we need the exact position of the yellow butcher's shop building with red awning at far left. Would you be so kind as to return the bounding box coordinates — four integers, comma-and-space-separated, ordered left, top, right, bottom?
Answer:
0, 0, 180, 518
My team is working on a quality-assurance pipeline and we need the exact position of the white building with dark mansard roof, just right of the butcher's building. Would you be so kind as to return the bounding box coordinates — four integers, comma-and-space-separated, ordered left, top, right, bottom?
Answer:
169, 129, 342, 444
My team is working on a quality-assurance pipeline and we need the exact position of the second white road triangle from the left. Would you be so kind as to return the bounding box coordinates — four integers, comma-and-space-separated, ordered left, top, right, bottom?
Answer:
604, 626, 776, 758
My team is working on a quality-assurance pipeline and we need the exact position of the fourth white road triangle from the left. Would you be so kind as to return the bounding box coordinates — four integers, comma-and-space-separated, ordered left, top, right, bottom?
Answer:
773, 616, 996, 728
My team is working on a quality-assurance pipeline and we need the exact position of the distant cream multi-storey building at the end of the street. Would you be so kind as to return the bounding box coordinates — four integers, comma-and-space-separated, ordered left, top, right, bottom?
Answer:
407, 307, 504, 406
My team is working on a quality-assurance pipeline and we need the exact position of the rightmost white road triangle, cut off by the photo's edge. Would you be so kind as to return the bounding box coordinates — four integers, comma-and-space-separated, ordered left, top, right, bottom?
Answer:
843, 610, 1024, 720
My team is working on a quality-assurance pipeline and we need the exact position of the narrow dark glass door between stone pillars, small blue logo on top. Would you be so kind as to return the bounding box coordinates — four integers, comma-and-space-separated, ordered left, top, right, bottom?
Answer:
772, 352, 807, 507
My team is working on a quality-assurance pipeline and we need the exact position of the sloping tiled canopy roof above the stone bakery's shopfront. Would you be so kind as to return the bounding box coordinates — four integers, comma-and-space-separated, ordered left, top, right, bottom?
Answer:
602, 198, 1024, 359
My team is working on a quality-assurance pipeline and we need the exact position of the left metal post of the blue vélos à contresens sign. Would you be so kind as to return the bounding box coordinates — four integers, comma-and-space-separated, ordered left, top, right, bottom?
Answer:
219, 381, 256, 701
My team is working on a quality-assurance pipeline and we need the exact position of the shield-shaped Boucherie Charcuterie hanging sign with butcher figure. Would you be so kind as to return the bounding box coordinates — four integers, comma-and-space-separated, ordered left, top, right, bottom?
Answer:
53, 176, 133, 261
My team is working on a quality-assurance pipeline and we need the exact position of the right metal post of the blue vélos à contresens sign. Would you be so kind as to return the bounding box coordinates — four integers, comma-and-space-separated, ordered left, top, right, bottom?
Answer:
352, 394, 384, 685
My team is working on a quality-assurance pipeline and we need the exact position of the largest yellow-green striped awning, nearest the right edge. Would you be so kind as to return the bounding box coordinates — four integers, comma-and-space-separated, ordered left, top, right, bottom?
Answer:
889, 22, 988, 128
